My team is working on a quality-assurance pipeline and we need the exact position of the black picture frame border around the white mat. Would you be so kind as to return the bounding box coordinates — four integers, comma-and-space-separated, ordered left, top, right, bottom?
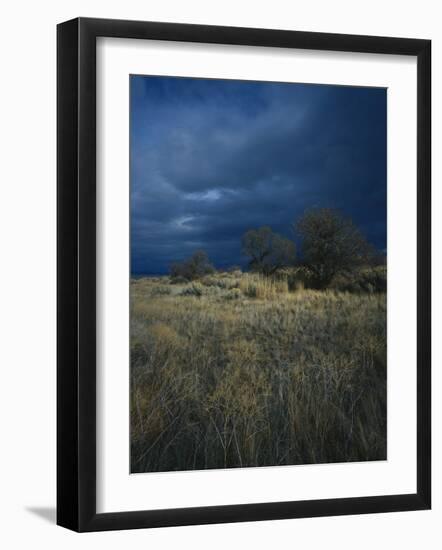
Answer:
57, 18, 431, 532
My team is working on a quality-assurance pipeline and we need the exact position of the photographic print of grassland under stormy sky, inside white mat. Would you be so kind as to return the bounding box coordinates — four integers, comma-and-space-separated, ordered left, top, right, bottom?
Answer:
129, 75, 387, 473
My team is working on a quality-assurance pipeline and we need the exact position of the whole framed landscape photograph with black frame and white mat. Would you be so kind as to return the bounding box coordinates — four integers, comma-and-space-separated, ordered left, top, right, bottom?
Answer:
57, 18, 431, 531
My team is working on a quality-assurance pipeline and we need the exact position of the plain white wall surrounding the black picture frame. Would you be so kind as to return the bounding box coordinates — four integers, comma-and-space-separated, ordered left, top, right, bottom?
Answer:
0, 0, 442, 550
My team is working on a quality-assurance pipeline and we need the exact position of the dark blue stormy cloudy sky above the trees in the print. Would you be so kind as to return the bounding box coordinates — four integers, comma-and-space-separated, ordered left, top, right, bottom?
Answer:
130, 76, 386, 274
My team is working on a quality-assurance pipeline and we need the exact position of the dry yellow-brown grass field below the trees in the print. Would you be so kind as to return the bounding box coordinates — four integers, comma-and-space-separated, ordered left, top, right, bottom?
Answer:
131, 272, 386, 472
